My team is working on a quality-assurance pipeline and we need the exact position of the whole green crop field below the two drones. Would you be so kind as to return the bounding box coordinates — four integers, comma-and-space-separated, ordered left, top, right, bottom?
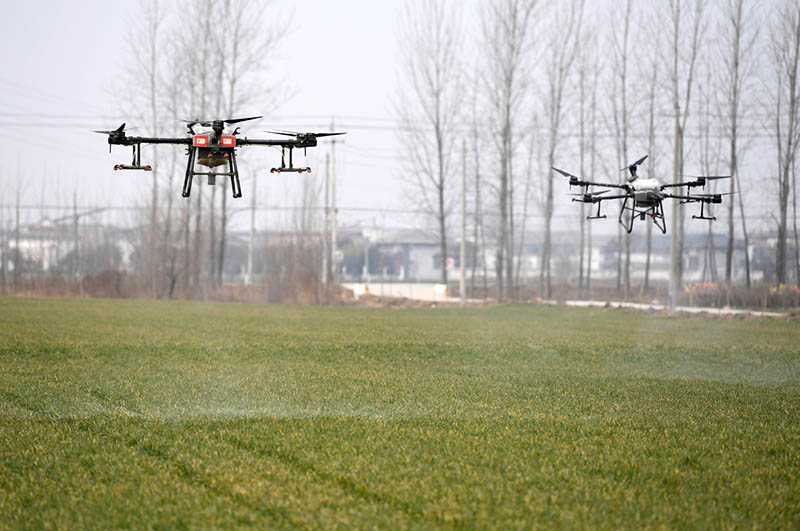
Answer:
0, 298, 800, 529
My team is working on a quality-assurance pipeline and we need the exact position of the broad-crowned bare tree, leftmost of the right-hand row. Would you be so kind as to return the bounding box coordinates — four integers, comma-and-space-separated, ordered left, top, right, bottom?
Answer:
395, 0, 462, 284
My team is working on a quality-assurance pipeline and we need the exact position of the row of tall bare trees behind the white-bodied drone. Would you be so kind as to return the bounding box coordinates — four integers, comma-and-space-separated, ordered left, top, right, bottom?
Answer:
396, 0, 800, 299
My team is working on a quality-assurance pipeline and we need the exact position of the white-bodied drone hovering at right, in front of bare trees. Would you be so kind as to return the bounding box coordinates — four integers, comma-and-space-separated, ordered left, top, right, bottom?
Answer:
551, 155, 734, 234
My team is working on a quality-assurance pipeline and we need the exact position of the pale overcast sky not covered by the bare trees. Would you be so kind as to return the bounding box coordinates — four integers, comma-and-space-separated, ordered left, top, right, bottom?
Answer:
0, 0, 784, 238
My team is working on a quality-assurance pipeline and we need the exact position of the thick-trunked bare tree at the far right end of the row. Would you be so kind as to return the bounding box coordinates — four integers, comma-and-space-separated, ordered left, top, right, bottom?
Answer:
770, 1, 800, 285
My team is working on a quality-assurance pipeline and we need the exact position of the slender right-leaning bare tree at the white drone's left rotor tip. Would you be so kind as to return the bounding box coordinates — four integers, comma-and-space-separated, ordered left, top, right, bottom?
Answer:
539, 0, 584, 297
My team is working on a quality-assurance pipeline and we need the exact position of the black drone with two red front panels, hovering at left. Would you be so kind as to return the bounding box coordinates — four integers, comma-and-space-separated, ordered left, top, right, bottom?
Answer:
93, 116, 345, 199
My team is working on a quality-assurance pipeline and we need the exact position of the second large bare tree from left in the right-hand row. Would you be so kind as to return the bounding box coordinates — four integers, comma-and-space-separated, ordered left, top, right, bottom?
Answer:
482, 0, 536, 299
